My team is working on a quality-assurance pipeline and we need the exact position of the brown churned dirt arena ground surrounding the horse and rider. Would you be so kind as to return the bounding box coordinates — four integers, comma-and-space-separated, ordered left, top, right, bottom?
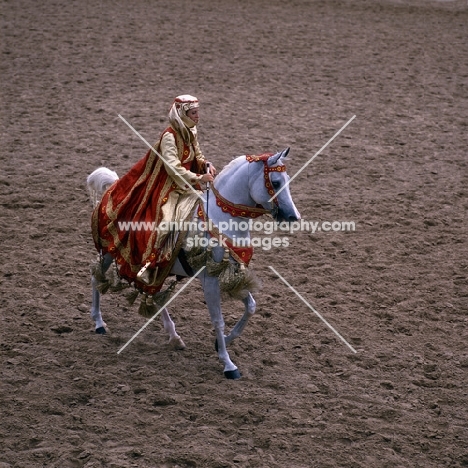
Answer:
0, 0, 468, 468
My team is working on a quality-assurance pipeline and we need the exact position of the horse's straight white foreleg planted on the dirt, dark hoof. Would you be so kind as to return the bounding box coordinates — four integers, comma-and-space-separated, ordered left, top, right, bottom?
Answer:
200, 273, 241, 379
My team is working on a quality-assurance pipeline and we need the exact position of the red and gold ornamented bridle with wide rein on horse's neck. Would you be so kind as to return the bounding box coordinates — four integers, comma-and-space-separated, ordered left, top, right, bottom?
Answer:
211, 153, 286, 219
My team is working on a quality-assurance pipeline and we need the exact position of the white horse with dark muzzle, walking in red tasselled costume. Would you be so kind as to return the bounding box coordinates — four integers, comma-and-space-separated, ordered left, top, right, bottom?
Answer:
87, 148, 300, 379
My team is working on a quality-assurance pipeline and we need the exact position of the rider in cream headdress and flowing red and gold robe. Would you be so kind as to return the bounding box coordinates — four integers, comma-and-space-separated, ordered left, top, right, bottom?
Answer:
92, 94, 216, 293
